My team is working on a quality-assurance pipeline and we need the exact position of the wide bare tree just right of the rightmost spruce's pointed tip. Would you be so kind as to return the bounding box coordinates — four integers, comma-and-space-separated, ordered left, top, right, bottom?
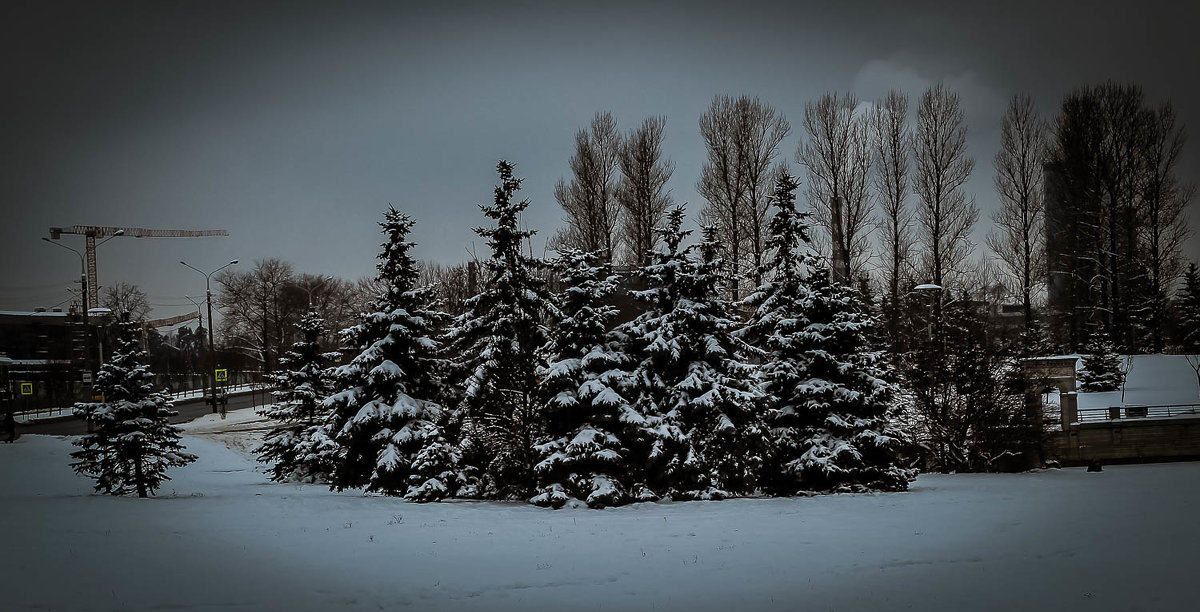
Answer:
796, 94, 871, 283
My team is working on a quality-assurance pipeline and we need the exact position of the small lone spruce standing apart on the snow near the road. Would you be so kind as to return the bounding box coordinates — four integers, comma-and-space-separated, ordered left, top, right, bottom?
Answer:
71, 313, 196, 497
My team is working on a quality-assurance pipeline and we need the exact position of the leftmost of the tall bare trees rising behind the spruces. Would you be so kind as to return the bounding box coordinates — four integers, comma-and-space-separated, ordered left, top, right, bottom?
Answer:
552, 112, 620, 260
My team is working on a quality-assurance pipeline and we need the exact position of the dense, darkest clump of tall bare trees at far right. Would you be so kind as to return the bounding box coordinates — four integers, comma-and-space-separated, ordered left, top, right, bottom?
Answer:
1045, 83, 1195, 352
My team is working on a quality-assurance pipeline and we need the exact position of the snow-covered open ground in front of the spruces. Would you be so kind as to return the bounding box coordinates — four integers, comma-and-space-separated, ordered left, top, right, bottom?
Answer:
0, 410, 1200, 612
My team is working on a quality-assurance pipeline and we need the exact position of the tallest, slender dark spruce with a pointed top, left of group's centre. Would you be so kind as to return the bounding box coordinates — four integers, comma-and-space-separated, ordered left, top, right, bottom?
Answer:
445, 161, 554, 499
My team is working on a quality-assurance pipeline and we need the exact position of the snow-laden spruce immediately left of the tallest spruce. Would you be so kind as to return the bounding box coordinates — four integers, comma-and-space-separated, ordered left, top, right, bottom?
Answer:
323, 208, 462, 502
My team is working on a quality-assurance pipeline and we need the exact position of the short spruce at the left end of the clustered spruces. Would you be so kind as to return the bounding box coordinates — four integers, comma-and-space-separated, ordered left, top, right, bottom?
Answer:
257, 312, 336, 482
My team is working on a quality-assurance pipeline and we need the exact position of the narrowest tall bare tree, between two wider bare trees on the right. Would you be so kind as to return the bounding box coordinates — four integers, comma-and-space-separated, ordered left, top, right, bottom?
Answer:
871, 91, 912, 341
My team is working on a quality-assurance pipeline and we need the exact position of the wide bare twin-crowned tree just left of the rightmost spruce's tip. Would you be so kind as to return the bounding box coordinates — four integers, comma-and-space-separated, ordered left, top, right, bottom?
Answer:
696, 96, 792, 300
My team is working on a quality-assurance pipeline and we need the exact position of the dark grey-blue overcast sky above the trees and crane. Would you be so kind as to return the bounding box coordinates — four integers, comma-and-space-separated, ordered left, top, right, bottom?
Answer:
0, 1, 1200, 316
